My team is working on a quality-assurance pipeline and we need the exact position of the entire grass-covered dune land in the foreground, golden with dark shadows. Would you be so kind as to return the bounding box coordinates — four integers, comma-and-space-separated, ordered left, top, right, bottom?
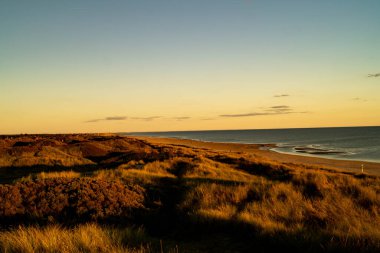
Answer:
0, 135, 380, 252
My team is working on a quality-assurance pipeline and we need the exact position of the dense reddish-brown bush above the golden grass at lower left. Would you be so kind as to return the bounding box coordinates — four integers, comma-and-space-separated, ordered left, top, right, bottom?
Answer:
0, 178, 144, 219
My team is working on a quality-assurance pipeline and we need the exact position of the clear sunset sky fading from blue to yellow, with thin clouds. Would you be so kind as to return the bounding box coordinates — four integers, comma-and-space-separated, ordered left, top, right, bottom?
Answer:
0, 0, 380, 134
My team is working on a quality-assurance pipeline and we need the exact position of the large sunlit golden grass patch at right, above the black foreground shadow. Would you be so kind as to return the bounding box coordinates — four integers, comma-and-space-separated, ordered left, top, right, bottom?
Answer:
182, 167, 380, 247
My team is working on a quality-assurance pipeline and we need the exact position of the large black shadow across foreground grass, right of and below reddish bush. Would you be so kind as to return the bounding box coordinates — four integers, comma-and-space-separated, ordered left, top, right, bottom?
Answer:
0, 174, 380, 252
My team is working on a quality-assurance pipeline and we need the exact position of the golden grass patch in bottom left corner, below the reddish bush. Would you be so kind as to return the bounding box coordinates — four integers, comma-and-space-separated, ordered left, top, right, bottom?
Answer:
0, 224, 150, 253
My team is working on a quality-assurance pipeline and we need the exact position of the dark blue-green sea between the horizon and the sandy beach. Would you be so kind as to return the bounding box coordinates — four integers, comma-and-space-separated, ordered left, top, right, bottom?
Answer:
121, 127, 380, 162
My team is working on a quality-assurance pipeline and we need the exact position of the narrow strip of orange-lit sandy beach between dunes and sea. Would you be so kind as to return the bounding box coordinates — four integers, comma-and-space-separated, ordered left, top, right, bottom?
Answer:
128, 135, 380, 176
